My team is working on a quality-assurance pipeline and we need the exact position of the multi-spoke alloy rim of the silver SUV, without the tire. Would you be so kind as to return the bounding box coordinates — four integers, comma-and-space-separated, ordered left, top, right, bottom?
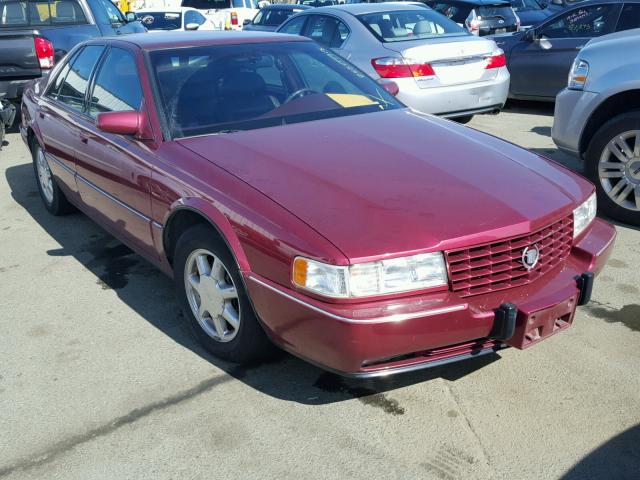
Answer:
598, 130, 640, 211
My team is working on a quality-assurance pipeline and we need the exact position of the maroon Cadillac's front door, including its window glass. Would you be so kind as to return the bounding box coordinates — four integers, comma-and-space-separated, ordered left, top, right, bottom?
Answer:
76, 47, 154, 255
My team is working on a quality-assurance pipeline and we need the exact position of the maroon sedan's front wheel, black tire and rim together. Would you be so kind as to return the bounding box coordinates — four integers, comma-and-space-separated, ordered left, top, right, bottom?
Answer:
173, 225, 275, 363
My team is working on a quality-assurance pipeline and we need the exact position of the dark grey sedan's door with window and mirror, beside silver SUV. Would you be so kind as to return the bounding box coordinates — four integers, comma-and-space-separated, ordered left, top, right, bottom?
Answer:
509, 3, 620, 100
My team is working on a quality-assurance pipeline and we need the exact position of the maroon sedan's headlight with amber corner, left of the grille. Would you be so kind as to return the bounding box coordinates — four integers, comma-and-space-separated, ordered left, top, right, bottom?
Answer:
293, 252, 447, 298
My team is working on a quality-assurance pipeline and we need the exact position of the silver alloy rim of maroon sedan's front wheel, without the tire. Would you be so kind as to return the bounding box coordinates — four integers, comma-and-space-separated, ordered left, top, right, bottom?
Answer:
184, 249, 241, 342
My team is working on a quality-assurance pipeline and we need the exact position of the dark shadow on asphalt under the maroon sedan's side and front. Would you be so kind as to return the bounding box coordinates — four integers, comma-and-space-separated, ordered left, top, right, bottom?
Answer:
6, 164, 500, 406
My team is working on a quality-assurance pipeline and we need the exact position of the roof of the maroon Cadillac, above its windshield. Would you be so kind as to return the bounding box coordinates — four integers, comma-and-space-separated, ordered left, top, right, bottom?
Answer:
92, 31, 313, 50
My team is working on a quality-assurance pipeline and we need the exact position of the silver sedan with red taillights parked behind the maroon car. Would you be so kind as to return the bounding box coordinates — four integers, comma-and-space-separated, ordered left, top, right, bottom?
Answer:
278, 3, 509, 121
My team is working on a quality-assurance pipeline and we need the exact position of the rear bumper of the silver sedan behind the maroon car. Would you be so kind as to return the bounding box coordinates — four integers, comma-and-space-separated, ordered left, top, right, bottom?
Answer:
394, 68, 509, 118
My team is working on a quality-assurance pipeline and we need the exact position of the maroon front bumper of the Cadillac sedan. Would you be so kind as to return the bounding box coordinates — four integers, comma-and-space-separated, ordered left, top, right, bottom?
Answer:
245, 219, 615, 377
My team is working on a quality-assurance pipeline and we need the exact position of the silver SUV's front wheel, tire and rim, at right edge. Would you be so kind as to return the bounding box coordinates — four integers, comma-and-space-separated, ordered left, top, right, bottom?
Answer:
585, 111, 640, 226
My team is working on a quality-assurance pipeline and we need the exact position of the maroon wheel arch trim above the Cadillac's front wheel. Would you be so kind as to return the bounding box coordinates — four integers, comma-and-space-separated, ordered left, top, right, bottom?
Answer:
162, 198, 251, 272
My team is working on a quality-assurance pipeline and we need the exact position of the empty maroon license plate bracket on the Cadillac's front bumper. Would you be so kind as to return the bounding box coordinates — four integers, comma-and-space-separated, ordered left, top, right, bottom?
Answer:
506, 294, 578, 349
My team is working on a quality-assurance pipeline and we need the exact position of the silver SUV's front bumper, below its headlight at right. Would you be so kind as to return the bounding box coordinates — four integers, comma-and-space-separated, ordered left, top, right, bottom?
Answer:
551, 88, 599, 156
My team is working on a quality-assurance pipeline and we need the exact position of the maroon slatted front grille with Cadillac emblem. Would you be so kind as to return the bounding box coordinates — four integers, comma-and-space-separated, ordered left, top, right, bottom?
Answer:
445, 215, 573, 297
